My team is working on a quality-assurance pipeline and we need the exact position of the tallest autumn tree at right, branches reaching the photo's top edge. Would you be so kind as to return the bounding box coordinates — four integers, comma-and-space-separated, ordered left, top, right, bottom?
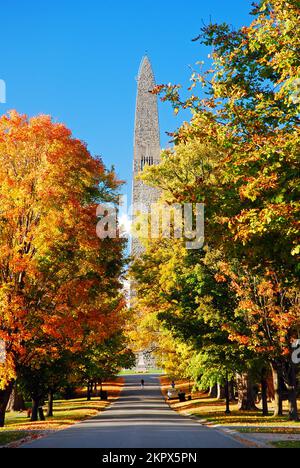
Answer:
132, 0, 300, 420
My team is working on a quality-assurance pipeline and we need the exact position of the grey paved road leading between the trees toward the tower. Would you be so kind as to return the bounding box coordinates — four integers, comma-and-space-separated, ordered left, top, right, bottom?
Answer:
23, 375, 243, 449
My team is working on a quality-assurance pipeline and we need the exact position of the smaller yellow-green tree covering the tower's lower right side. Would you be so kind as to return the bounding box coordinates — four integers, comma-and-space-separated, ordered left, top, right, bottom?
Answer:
131, 238, 254, 405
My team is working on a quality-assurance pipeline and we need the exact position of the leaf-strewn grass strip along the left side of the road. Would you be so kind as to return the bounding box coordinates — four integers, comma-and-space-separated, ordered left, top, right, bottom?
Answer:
0, 378, 123, 446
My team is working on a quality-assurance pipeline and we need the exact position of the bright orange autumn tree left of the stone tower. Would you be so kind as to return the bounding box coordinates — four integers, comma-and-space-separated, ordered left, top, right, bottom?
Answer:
0, 112, 123, 426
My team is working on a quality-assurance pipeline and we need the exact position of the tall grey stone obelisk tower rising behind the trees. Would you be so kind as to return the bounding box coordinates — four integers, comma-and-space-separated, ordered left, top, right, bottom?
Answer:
131, 57, 160, 257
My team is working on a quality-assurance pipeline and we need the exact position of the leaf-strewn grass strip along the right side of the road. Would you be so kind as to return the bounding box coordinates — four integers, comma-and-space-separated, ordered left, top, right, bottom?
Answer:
161, 376, 300, 434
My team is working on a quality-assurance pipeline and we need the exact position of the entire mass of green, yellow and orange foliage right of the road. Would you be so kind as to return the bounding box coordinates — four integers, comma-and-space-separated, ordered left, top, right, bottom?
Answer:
133, 0, 300, 420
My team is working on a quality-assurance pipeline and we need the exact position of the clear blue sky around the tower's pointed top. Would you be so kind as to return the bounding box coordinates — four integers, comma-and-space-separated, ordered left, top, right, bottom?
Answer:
0, 0, 251, 199
